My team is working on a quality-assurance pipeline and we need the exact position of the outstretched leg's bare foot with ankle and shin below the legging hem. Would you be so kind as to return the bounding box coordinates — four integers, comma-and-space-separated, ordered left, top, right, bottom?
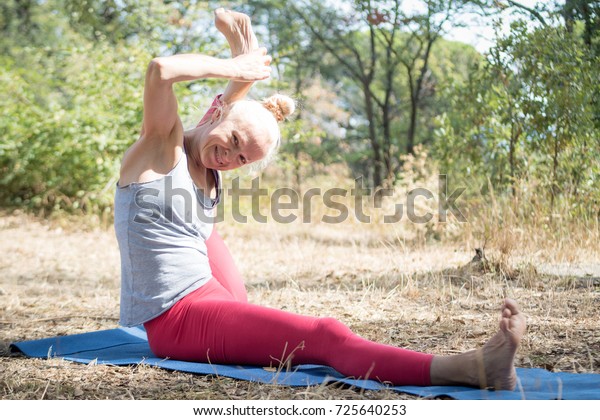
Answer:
431, 299, 527, 390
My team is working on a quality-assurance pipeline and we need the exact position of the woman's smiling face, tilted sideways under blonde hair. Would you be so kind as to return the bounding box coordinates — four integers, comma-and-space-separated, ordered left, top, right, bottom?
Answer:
200, 105, 278, 171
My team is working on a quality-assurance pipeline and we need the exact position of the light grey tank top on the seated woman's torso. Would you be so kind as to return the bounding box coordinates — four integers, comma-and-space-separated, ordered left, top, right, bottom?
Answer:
114, 153, 221, 327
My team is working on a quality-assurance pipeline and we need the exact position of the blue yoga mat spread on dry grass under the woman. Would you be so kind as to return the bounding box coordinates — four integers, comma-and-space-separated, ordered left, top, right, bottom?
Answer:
11, 327, 600, 400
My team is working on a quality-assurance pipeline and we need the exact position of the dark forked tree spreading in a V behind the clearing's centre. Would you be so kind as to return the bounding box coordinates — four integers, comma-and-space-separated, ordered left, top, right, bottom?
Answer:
258, 0, 474, 185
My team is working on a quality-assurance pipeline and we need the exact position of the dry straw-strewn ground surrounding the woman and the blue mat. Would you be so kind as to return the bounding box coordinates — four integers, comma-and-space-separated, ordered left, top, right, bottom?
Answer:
0, 214, 600, 400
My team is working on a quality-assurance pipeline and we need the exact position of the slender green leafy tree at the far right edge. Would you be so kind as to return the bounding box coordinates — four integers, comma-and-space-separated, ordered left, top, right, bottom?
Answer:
506, 20, 600, 210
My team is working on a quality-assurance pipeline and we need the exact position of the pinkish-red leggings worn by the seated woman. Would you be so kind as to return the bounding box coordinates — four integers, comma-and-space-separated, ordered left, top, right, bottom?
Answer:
144, 230, 433, 385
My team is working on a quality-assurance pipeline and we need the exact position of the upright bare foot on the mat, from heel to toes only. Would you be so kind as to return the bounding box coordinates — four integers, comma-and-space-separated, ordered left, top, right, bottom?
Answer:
478, 299, 527, 390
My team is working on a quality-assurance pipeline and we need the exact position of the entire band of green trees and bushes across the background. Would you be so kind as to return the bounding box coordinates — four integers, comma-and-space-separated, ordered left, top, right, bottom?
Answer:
0, 0, 600, 225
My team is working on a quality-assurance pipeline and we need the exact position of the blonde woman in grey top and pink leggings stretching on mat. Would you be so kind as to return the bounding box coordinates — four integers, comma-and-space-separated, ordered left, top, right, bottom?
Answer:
115, 9, 525, 389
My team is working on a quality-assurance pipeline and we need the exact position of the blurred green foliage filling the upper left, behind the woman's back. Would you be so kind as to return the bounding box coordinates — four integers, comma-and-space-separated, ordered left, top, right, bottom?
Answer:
0, 0, 213, 214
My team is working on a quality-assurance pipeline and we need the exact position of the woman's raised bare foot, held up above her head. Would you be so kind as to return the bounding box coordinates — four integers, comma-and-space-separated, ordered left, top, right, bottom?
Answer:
215, 7, 258, 57
